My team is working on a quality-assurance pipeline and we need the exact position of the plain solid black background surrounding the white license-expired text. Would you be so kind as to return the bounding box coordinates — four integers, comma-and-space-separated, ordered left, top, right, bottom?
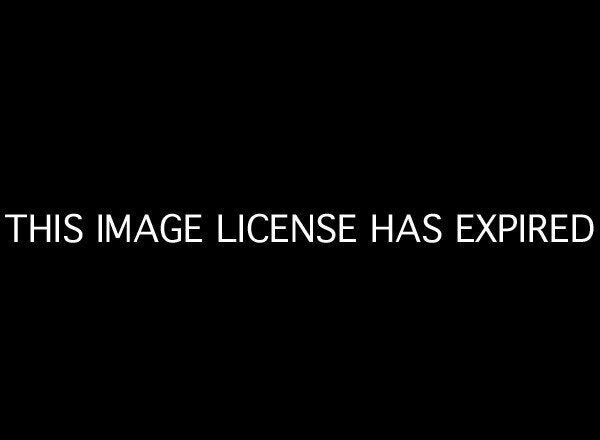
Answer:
1, 5, 598, 433
